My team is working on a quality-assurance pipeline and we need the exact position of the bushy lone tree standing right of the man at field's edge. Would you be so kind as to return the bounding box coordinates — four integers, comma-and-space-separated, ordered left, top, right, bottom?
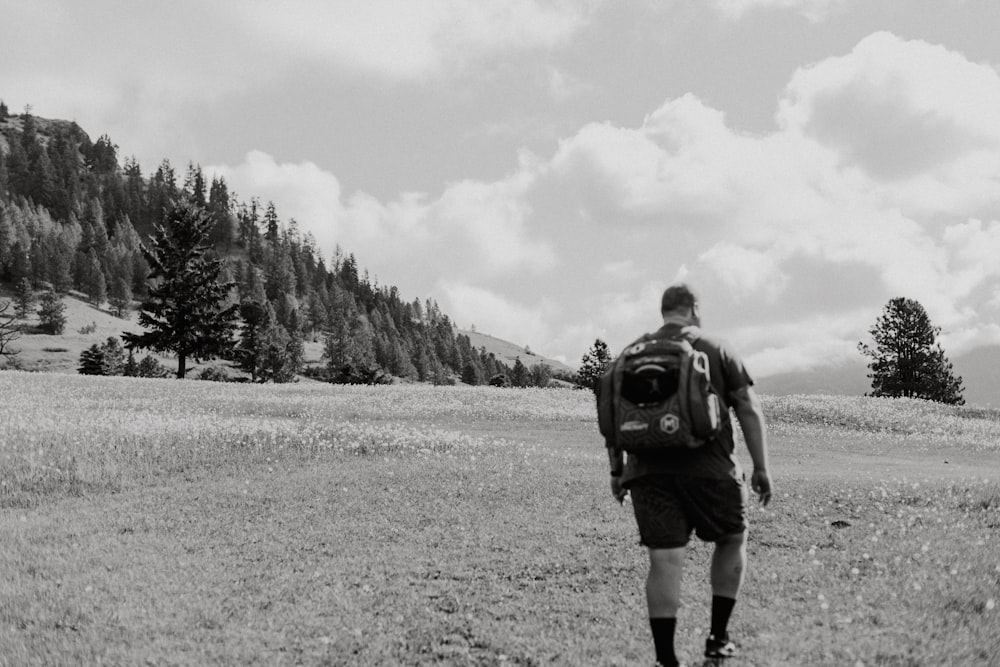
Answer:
858, 297, 965, 405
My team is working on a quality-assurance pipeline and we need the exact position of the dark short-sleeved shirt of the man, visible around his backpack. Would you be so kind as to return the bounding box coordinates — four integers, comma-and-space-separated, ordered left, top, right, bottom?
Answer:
622, 323, 753, 486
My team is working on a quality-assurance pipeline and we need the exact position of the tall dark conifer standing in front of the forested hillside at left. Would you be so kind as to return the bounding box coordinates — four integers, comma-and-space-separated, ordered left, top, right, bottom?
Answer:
122, 201, 239, 378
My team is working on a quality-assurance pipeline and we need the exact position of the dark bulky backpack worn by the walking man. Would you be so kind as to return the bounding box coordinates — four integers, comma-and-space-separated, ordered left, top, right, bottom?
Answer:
597, 330, 722, 453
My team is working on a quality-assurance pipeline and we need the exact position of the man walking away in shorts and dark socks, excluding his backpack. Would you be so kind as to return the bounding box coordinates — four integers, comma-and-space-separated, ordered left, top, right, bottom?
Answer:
606, 284, 772, 667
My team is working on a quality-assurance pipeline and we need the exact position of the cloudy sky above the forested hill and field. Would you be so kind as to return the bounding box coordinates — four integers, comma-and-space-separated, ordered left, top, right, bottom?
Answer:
0, 0, 1000, 376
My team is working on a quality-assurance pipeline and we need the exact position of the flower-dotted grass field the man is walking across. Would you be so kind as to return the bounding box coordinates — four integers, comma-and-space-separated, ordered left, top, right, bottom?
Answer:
0, 372, 1000, 666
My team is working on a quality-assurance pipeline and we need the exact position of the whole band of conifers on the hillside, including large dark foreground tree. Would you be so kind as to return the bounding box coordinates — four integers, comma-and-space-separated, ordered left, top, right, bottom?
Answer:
0, 107, 564, 386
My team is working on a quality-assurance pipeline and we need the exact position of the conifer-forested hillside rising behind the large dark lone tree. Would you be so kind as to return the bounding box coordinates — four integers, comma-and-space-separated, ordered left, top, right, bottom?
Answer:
0, 103, 560, 384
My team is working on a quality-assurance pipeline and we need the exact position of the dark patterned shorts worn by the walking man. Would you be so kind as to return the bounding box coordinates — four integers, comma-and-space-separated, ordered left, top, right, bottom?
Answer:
629, 475, 748, 549
